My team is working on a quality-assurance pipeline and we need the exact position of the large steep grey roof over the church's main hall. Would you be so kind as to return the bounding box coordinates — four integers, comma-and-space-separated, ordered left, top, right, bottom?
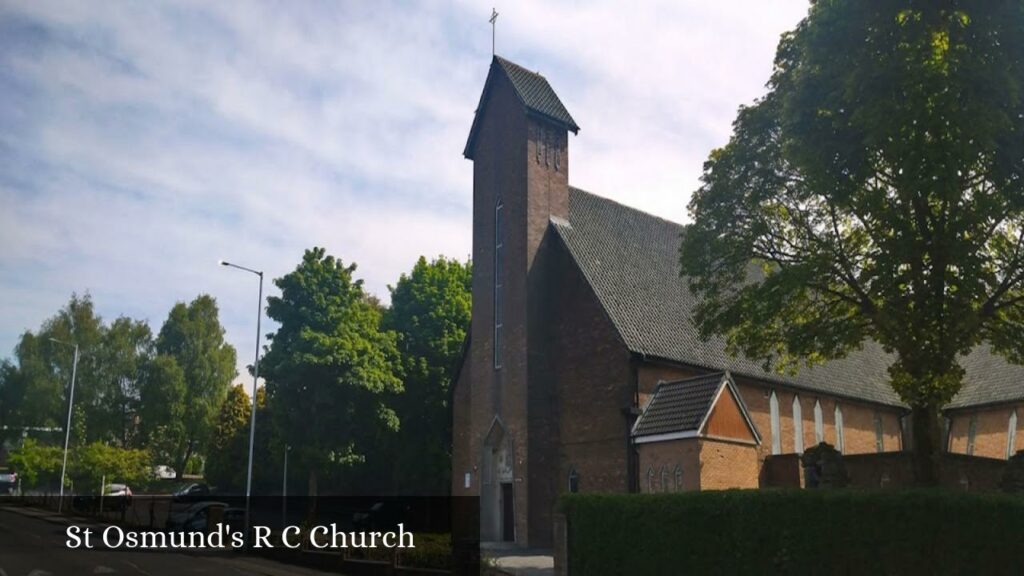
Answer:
552, 188, 1024, 408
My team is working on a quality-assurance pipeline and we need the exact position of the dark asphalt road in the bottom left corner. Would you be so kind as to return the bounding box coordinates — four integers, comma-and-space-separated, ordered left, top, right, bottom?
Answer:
0, 507, 327, 576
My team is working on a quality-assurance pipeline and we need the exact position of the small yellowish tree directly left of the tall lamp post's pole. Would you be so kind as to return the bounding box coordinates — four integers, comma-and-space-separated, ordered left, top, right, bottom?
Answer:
206, 384, 252, 490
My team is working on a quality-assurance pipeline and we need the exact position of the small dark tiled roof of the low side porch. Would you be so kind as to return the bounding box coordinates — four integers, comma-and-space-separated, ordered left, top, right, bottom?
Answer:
633, 372, 725, 437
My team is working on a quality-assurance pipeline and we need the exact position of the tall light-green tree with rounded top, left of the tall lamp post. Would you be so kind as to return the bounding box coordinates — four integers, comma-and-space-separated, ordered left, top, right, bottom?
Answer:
157, 294, 237, 477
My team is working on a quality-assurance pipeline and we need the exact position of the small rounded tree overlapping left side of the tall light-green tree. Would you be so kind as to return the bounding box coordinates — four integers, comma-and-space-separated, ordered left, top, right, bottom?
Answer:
138, 355, 188, 470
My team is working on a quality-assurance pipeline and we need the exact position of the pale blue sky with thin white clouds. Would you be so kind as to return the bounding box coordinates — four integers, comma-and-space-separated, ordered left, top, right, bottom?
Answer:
0, 0, 808, 381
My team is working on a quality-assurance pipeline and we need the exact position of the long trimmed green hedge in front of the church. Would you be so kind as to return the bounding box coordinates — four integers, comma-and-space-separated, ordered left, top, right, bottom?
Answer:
560, 490, 1024, 576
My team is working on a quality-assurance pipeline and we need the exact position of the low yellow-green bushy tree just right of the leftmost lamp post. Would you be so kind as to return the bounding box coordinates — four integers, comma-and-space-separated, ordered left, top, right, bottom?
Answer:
70, 442, 153, 492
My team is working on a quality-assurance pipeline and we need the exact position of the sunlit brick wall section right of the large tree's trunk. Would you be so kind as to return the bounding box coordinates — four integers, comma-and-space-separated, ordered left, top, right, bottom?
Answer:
947, 404, 1024, 459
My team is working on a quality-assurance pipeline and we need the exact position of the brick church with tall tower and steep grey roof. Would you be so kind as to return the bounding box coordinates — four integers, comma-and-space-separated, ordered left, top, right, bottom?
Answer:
453, 56, 1024, 546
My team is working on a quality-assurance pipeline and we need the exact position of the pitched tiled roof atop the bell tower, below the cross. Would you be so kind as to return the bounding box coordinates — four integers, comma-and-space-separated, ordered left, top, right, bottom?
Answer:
463, 55, 580, 158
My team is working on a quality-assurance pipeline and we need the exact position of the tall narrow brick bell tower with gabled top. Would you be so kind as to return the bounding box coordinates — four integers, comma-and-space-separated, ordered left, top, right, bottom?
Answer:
462, 56, 580, 546
